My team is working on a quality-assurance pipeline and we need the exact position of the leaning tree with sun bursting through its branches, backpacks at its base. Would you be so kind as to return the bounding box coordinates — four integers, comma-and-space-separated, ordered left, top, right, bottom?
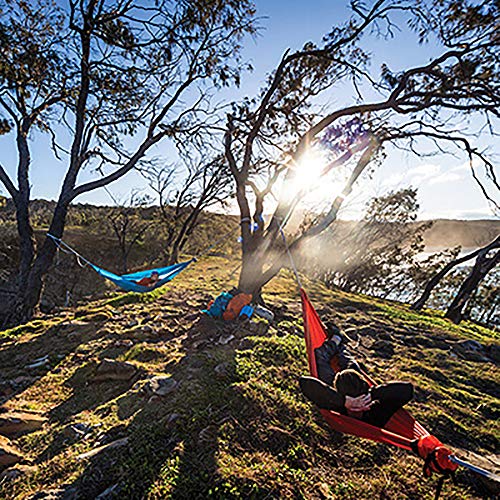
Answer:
224, 0, 500, 293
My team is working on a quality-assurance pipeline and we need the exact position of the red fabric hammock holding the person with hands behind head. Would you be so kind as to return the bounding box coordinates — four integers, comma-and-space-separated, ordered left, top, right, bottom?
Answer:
300, 289, 430, 451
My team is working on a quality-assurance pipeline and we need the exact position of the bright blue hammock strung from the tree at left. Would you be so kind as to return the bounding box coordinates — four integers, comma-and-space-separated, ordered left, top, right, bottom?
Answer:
47, 234, 196, 293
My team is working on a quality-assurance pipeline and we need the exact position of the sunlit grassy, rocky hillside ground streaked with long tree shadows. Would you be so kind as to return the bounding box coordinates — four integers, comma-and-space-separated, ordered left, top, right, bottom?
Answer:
0, 257, 500, 499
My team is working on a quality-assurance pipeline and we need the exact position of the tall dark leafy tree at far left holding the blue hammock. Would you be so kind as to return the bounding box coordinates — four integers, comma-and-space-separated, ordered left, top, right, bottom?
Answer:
0, 0, 255, 325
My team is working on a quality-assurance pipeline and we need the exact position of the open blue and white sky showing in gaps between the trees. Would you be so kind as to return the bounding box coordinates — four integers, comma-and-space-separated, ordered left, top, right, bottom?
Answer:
0, 0, 498, 219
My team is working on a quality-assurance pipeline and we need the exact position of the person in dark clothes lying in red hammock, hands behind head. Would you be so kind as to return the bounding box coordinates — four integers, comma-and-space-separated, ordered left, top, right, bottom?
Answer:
300, 324, 413, 427
